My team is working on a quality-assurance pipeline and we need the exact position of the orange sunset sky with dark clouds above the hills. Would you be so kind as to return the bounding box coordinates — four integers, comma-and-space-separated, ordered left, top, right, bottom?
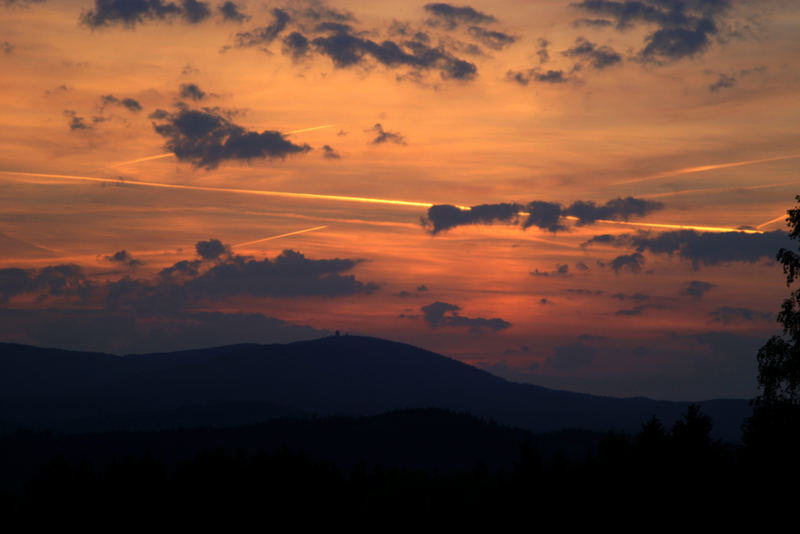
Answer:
0, 0, 800, 400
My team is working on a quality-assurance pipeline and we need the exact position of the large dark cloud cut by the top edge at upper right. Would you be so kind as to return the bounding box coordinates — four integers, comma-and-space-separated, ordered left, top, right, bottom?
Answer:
572, 0, 730, 63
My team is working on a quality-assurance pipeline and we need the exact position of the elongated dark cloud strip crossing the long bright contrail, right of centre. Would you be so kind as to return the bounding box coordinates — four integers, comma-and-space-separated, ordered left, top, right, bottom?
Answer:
423, 197, 664, 234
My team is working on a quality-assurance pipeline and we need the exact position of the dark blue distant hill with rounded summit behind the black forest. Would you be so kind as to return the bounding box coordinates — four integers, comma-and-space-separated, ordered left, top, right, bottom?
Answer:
0, 336, 749, 442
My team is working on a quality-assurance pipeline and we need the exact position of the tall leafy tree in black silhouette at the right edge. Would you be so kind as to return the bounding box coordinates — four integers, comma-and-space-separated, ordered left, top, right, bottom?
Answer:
743, 195, 800, 470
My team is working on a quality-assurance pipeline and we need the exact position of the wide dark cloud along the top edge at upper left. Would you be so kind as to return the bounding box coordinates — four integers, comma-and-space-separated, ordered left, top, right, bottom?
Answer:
80, 0, 211, 29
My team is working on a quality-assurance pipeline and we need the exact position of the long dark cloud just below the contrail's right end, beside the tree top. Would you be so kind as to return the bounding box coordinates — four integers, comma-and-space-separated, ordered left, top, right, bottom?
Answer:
583, 230, 790, 268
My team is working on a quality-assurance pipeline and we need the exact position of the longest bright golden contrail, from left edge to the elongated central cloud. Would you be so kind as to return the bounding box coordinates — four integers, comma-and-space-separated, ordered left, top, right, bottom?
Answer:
0, 171, 440, 208
